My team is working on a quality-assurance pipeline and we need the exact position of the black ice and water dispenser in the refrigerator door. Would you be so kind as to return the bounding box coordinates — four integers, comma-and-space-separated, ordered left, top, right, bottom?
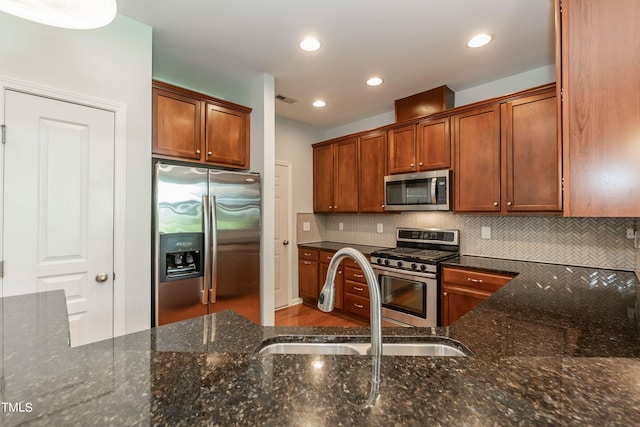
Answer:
160, 233, 204, 282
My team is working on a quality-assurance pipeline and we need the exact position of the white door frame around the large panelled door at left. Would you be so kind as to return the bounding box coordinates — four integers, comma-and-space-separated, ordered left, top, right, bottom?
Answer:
0, 75, 127, 337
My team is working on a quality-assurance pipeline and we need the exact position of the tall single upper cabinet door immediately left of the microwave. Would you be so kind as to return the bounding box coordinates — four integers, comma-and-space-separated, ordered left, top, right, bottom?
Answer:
358, 131, 387, 212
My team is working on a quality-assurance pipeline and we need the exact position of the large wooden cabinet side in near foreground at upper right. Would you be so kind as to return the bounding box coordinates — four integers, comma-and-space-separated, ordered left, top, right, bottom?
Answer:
556, 0, 640, 217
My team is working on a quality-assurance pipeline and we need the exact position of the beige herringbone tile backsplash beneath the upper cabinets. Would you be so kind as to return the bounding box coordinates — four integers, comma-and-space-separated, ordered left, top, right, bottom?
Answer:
297, 212, 639, 270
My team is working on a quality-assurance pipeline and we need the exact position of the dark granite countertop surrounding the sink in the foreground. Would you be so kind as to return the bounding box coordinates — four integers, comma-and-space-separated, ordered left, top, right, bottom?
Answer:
0, 256, 640, 426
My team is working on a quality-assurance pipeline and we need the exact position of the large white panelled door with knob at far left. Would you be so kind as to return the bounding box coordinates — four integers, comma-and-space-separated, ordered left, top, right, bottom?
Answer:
2, 90, 115, 345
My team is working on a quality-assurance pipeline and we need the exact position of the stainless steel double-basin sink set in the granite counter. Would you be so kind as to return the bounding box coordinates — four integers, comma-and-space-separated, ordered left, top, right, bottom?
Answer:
259, 338, 468, 357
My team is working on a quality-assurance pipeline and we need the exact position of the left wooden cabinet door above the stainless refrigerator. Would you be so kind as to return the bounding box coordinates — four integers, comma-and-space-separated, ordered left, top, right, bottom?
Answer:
152, 88, 202, 160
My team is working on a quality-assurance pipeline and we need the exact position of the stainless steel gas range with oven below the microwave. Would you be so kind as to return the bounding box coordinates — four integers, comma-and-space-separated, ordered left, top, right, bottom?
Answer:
371, 228, 460, 327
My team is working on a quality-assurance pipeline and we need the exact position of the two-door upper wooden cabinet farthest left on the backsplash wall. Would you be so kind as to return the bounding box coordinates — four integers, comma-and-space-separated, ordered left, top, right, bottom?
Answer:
313, 137, 358, 213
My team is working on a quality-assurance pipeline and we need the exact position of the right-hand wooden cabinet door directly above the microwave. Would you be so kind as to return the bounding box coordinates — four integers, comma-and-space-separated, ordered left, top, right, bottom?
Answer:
416, 117, 451, 171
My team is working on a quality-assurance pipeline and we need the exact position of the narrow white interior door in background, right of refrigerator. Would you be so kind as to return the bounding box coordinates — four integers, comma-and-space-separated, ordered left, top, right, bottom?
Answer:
274, 163, 291, 309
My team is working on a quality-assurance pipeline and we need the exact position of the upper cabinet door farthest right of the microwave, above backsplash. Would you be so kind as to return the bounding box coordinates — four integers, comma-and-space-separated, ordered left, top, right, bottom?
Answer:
502, 92, 562, 212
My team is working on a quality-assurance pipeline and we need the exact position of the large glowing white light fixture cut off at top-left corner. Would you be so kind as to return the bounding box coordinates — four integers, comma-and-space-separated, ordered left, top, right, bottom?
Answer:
0, 0, 118, 30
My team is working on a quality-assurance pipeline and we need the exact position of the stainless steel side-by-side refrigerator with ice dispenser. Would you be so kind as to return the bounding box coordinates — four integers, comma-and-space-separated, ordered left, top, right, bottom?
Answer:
152, 162, 261, 326
